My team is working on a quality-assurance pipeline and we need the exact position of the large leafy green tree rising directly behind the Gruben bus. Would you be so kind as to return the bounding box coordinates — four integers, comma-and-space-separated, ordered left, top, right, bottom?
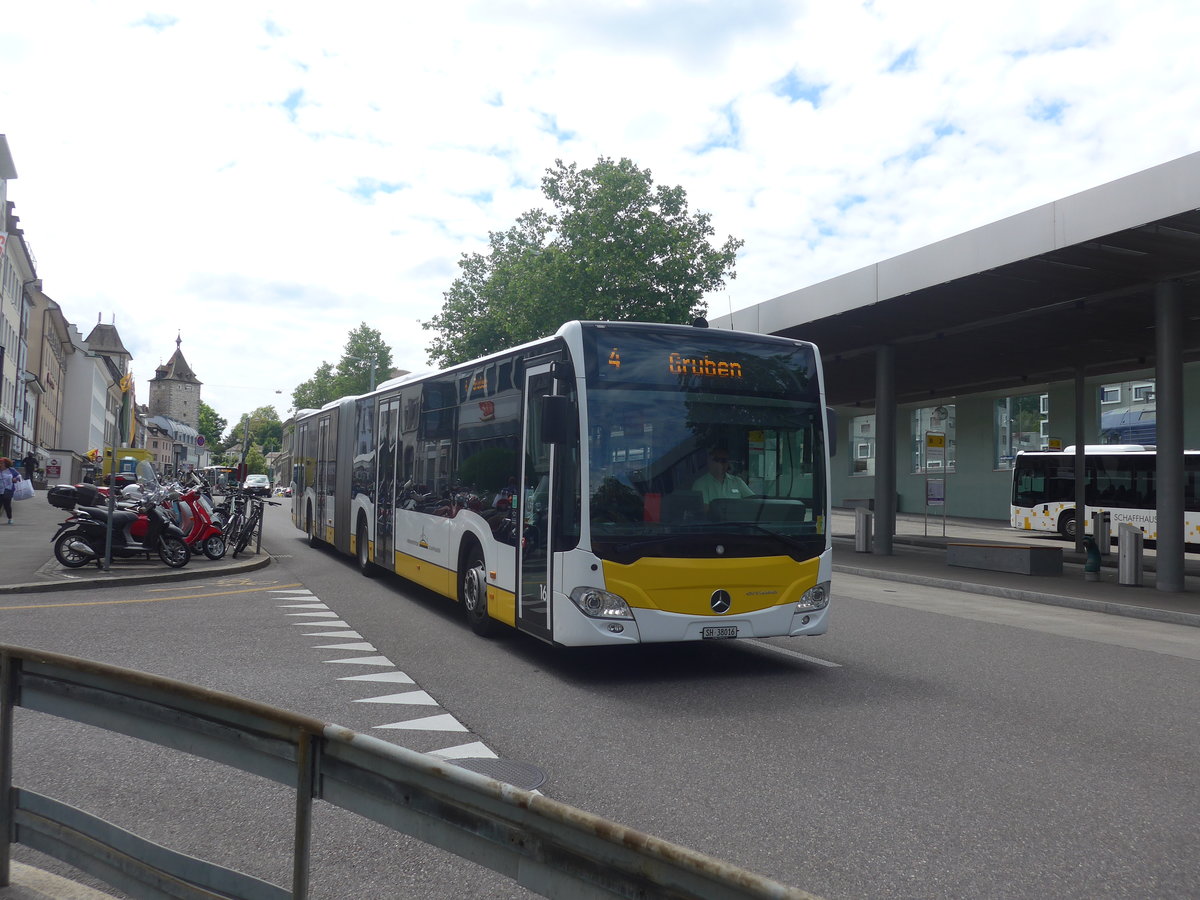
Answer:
421, 157, 743, 365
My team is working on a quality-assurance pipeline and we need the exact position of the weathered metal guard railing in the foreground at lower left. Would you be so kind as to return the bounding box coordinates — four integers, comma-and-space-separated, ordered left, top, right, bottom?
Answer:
0, 644, 812, 900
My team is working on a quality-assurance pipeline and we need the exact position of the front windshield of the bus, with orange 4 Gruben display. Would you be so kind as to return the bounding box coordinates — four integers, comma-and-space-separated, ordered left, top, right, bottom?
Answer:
584, 328, 826, 562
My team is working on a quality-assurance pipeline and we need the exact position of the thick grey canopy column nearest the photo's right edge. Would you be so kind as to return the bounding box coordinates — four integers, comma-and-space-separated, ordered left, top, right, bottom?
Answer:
1154, 281, 1184, 592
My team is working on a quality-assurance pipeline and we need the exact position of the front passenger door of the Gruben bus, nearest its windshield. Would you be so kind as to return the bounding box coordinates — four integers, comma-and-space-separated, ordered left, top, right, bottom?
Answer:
517, 362, 556, 640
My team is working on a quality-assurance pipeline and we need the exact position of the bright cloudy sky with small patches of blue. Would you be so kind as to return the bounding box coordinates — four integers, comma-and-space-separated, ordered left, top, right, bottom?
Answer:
0, 0, 1200, 434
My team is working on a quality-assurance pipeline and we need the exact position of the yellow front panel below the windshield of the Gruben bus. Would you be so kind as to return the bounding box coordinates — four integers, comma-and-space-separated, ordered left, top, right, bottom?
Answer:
604, 557, 821, 616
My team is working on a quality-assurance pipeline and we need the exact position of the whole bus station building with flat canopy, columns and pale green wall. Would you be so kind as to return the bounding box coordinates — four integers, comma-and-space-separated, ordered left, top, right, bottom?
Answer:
712, 152, 1200, 589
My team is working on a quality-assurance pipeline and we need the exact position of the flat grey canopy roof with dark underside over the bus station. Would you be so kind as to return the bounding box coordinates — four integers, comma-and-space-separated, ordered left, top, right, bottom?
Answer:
713, 152, 1200, 408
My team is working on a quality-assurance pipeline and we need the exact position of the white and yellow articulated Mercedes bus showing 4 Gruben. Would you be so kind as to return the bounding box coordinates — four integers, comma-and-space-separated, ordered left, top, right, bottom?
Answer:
293, 322, 832, 646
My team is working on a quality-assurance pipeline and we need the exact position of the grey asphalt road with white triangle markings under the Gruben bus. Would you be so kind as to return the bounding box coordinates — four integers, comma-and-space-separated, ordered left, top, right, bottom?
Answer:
0, 509, 1200, 898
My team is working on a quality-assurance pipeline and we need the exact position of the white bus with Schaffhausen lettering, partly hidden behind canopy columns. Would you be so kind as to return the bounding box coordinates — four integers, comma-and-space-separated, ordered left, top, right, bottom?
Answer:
1009, 444, 1200, 544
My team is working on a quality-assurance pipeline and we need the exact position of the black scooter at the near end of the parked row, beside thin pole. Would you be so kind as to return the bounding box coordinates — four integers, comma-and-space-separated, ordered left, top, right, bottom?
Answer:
50, 462, 192, 569
